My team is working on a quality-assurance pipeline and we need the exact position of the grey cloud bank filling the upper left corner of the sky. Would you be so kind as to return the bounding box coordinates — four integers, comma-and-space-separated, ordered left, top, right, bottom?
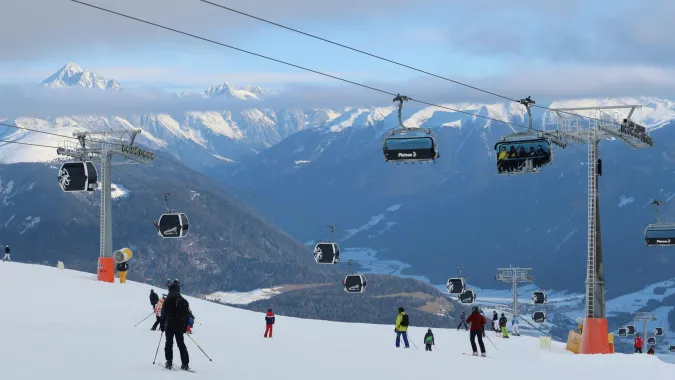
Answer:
0, 0, 439, 62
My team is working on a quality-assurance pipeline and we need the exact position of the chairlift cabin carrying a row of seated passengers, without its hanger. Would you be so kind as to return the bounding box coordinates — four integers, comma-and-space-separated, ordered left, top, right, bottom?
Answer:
495, 136, 553, 174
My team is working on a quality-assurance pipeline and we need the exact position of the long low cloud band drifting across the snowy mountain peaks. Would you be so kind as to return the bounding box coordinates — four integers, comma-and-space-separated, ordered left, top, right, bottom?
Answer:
0, 66, 675, 118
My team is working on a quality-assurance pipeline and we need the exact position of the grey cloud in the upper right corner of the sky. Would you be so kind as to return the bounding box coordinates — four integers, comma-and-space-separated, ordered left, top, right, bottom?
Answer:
445, 0, 675, 66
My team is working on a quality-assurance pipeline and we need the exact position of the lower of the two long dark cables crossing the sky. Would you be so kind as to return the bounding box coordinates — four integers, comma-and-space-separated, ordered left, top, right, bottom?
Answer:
70, 0, 537, 130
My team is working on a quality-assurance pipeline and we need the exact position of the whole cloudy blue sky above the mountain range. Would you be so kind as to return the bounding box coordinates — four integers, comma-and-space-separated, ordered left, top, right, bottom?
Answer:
0, 0, 675, 114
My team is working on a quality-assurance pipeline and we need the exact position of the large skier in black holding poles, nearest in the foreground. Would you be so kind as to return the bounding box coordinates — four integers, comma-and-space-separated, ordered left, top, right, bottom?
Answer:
160, 280, 190, 371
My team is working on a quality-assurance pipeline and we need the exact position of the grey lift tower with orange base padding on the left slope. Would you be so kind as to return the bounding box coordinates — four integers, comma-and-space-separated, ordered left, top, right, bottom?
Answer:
56, 129, 155, 280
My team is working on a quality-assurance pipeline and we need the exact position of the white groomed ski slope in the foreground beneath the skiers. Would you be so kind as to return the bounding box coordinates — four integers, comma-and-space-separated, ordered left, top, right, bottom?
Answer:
0, 262, 675, 380
